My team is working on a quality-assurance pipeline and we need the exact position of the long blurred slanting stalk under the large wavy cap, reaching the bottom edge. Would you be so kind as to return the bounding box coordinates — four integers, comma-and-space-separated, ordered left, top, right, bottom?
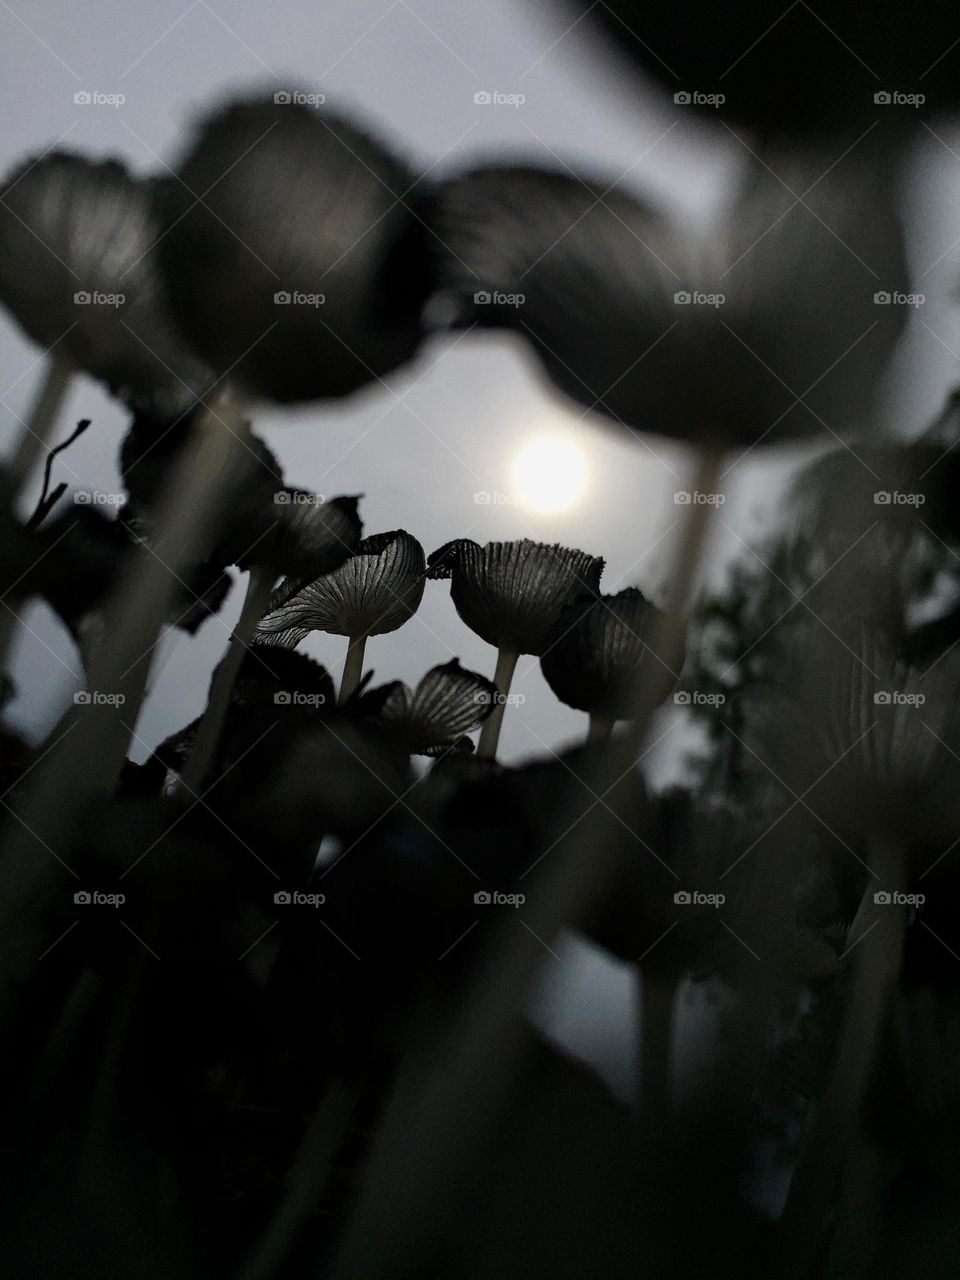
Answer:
333, 451, 722, 1280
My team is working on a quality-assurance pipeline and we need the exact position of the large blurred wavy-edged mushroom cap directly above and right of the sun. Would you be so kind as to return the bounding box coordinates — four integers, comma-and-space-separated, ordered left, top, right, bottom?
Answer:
436, 156, 909, 445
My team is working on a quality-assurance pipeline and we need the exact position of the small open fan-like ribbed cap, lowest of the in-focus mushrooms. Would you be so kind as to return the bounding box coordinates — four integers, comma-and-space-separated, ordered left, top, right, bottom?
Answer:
380, 658, 497, 755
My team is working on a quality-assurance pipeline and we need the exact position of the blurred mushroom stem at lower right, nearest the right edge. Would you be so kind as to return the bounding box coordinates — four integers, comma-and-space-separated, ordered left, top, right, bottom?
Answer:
771, 836, 908, 1280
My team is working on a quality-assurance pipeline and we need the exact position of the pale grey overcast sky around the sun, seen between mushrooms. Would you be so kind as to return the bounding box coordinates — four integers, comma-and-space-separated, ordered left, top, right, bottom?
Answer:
0, 0, 960, 1100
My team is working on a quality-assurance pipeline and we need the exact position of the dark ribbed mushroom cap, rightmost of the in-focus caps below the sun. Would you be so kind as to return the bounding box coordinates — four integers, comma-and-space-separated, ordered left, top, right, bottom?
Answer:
540, 586, 678, 719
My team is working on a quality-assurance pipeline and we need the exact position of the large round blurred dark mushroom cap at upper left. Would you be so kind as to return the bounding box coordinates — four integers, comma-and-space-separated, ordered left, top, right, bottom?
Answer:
160, 99, 429, 401
